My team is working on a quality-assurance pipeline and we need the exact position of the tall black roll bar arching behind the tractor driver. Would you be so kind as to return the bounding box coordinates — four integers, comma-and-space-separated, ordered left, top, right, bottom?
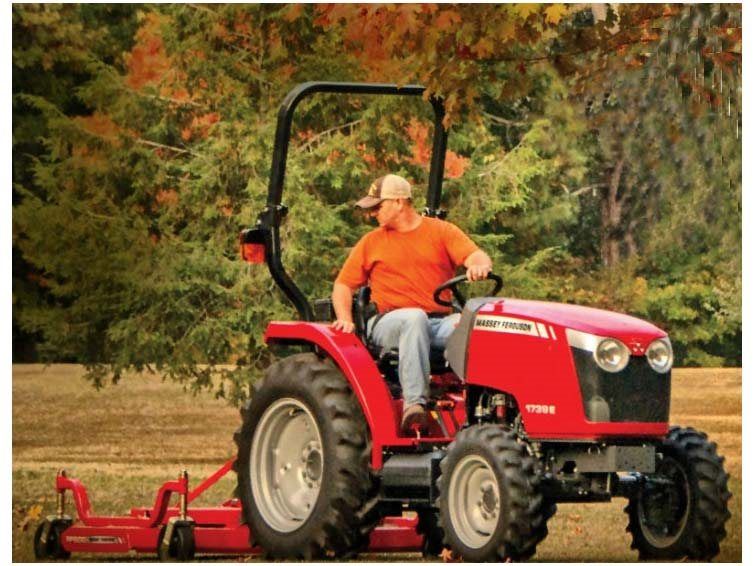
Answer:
248, 82, 448, 321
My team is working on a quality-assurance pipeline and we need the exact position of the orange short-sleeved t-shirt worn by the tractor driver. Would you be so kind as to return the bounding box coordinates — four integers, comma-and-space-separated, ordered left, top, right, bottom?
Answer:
336, 217, 478, 313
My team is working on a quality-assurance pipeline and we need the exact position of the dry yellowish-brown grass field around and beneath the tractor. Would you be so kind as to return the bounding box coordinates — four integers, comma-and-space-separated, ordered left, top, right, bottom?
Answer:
13, 365, 742, 562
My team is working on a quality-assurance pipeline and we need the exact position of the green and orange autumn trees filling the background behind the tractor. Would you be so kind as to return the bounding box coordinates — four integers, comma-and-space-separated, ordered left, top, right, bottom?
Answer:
12, 4, 742, 398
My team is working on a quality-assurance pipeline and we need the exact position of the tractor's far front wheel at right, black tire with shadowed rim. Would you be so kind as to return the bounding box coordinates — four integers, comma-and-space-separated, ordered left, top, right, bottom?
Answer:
625, 427, 731, 561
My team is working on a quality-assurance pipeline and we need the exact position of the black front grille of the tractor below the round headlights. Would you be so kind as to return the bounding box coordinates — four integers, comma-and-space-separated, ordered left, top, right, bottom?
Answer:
572, 348, 671, 423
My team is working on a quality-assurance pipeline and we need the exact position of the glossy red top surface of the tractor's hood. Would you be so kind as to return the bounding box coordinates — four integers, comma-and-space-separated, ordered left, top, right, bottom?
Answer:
478, 299, 666, 350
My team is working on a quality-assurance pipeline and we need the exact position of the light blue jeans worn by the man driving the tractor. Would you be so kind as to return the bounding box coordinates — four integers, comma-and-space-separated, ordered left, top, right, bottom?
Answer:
367, 308, 461, 407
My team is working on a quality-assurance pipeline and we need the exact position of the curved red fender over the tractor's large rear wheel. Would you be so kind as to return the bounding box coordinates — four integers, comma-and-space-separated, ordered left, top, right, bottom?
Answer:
264, 322, 417, 470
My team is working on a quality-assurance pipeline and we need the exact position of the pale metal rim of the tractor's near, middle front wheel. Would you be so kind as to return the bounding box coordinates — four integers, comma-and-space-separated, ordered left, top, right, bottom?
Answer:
448, 455, 501, 548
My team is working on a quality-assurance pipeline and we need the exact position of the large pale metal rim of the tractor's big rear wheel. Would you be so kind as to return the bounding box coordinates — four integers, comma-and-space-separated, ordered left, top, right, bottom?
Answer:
249, 398, 324, 533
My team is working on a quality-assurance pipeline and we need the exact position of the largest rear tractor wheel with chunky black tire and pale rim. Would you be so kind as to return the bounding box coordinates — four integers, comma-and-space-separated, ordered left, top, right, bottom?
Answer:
234, 354, 379, 560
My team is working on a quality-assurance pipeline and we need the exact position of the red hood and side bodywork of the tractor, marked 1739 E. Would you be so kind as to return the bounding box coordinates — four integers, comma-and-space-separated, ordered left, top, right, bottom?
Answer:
467, 299, 668, 440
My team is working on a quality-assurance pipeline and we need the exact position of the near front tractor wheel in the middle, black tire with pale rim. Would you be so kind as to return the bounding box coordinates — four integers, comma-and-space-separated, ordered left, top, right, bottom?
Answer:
438, 424, 555, 562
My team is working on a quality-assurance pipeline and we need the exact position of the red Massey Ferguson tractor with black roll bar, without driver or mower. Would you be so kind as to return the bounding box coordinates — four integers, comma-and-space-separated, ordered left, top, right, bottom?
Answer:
235, 83, 731, 561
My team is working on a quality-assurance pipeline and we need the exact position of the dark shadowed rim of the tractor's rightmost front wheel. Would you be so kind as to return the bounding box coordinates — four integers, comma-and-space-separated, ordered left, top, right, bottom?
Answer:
638, 458, 691, 548
